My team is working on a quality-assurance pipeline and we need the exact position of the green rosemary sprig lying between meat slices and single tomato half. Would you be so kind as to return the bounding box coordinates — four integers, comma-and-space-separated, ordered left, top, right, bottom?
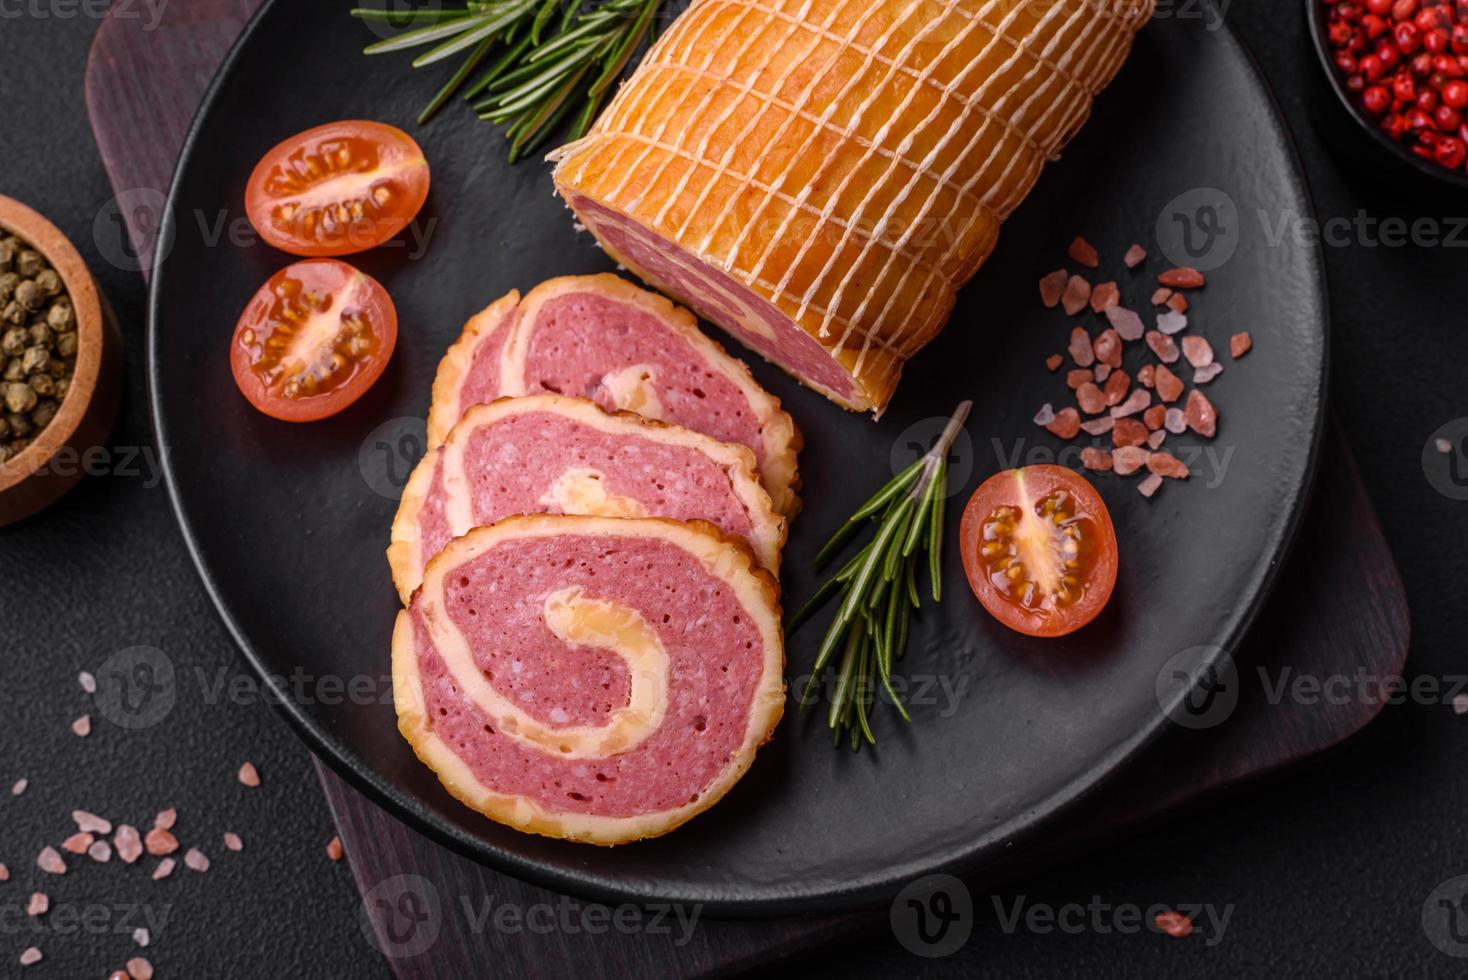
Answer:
785, 402, 973, 751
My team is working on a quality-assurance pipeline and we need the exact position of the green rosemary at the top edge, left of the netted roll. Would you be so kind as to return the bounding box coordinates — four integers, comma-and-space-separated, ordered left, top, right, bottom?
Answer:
352, 0, 665, 163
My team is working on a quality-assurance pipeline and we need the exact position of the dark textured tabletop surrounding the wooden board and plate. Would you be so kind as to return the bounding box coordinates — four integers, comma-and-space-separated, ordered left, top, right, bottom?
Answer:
0, 0, 1468, 977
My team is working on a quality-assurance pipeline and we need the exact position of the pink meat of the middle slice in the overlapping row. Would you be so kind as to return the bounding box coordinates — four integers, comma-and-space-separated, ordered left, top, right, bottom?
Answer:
418, 412, 753, 575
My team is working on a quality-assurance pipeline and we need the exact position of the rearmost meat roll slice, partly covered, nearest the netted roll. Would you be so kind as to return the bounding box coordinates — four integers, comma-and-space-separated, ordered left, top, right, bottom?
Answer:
429, 274, 800, 516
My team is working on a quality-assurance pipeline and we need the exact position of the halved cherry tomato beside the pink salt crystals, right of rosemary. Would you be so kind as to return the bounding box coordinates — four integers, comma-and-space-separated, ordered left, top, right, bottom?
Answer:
959, 465, 1117, 637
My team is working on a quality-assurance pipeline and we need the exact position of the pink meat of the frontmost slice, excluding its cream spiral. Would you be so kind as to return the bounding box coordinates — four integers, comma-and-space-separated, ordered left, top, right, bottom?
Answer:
413, 535, 763, 817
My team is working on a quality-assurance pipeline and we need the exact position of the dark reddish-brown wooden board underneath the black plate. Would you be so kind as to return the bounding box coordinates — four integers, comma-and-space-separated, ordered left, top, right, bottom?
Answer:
87, 0, 1409, 979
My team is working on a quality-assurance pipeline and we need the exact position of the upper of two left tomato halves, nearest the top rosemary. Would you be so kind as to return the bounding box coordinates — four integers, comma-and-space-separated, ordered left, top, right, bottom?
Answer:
245, 119, 429, 255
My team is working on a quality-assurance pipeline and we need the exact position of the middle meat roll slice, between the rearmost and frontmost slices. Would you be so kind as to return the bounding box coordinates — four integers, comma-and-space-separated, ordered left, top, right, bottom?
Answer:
388, 395, 785, 604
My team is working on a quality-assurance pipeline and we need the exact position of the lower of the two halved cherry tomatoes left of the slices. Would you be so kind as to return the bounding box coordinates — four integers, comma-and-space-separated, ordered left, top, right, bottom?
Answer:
229, 258, 398, 423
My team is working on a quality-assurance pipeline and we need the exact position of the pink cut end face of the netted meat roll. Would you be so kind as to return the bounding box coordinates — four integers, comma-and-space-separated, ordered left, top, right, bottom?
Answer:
571, 195, 856, 398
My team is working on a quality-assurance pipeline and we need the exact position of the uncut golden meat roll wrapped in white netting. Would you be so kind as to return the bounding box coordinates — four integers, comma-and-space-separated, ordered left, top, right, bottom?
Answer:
552, 0, 1154, 411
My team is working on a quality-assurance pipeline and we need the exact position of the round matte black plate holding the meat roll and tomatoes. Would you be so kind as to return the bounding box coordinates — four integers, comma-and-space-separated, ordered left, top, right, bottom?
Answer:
148, 3, 1326, 914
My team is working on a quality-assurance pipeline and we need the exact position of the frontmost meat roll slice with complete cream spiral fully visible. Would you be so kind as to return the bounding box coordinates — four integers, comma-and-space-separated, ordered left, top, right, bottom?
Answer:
392, 515, 785, 844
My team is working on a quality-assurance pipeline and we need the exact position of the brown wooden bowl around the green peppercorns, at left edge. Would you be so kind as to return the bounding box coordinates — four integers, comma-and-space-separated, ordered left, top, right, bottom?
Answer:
0, 195, 122, 525
